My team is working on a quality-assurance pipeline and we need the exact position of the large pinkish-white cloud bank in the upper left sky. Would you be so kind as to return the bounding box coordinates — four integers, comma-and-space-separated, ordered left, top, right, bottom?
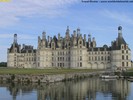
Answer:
0, 0, 78, 27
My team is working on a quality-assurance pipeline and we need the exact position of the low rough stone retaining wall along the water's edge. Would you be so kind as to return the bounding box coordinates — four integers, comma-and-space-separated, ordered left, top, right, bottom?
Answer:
0, 71, 104, 83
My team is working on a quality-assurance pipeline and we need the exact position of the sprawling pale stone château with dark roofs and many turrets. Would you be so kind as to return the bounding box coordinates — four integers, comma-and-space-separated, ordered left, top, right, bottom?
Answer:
7, 26, 131, 69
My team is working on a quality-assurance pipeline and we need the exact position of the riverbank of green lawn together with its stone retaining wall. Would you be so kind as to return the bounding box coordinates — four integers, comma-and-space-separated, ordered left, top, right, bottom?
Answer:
0, 68, 104, 83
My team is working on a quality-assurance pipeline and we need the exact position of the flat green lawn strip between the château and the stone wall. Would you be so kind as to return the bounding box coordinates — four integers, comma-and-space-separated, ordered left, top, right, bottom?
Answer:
0, 68, 101, 75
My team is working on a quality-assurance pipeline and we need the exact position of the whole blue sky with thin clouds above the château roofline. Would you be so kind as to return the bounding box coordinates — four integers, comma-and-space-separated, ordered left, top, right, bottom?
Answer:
0, 0, 133, 62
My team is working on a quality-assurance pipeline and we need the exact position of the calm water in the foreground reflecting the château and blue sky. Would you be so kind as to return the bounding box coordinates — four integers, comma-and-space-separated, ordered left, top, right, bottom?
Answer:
0, 79, 133, 100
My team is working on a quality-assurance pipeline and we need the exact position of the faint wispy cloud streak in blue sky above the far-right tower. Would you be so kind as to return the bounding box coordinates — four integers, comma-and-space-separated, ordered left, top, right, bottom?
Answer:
101, 10, 133, 25
